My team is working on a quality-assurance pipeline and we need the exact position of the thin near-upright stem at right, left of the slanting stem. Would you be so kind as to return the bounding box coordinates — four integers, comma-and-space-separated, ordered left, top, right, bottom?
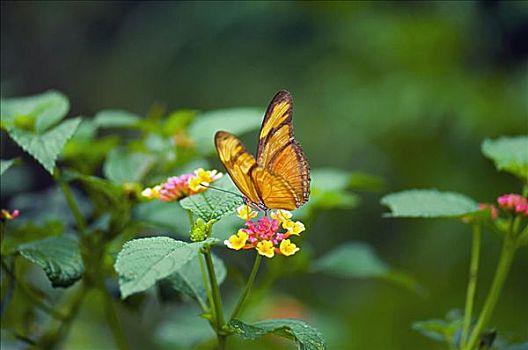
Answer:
460, 223, 481, 348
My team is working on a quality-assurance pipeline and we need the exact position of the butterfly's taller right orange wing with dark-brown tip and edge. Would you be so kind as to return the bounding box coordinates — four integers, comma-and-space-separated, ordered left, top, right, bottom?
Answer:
256, 90, 310, 209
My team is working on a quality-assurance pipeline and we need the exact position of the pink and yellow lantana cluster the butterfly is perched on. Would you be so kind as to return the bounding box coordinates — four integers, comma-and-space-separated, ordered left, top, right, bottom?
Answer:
224, 205, 305, 258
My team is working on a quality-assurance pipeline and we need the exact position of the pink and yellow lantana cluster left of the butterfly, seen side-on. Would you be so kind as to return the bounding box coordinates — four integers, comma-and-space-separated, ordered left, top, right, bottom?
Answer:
141, 168, 223, 202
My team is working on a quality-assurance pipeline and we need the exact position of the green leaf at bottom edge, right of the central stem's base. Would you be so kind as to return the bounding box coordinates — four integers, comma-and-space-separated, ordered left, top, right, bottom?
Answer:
229, 318, 326, 350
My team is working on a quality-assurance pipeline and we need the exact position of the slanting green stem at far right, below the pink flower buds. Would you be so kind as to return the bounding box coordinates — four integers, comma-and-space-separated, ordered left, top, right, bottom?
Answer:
464, 232, 516, 350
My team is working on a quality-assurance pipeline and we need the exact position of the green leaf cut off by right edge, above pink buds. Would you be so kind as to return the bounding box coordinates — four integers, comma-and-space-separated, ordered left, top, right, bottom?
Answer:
481, 136, 528, 181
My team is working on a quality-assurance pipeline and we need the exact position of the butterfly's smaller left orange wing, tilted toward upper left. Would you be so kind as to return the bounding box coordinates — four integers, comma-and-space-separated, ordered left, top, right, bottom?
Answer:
215, 131, 261, 203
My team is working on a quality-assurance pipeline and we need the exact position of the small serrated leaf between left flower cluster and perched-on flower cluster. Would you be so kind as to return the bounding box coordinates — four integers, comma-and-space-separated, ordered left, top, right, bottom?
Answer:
180, 189, 244, 222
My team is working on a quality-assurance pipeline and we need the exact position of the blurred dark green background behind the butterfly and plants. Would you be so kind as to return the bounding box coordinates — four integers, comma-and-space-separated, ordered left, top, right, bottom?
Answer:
1, 1, 528, 350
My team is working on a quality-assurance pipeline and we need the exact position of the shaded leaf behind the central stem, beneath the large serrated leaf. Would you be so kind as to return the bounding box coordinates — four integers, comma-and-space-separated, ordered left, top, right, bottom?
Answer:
167, 255, 227, 305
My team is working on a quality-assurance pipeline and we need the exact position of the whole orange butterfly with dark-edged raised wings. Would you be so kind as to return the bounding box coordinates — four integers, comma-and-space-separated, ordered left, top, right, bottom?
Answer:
215, 90, 310, 212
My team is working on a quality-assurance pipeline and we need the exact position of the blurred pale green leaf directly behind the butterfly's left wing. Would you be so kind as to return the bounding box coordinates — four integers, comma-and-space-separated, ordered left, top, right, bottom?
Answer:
189, 108, 264, 153
